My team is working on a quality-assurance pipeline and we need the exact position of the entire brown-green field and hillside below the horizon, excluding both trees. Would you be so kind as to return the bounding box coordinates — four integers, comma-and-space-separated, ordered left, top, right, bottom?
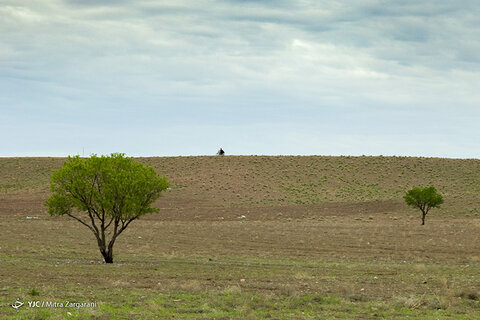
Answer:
0, 156, 480, 319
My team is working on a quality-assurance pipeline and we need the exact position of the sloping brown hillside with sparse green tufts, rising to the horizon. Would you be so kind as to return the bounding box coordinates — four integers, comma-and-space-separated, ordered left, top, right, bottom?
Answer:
0, 156, 480, 214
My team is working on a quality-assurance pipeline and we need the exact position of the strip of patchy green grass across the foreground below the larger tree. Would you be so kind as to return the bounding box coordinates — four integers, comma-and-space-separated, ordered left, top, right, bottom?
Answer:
0, 255, 480, 319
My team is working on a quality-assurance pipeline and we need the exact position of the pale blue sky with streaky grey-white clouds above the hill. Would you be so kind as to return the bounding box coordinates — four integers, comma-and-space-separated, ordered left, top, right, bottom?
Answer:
0, 0, 480, 158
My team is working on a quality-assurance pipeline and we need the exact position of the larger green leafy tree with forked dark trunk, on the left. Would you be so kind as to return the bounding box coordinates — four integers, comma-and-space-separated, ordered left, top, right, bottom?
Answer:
45, 153, 169, 263
